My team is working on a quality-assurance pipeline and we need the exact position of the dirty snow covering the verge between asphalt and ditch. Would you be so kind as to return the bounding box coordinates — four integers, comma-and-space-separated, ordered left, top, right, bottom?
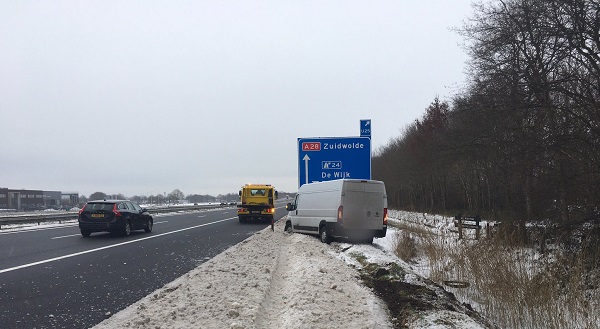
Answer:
94, 220, 485, 329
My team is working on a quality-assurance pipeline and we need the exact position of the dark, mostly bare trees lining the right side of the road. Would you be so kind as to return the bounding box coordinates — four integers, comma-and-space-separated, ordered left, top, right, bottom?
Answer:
372, 0, 600, 221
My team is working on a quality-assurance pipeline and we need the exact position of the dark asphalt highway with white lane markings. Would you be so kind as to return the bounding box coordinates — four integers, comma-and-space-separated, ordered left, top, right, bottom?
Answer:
0, 204, 286, 328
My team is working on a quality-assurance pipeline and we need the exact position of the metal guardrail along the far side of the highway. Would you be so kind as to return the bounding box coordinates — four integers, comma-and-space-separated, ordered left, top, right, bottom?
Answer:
0, 204, 234, 230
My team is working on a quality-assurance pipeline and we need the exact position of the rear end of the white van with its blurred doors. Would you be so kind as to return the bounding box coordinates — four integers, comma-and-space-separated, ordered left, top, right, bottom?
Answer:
342, 181, 387, 230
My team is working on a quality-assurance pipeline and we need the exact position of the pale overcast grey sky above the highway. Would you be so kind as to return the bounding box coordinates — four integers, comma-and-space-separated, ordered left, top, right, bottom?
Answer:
0, 0, 472, 196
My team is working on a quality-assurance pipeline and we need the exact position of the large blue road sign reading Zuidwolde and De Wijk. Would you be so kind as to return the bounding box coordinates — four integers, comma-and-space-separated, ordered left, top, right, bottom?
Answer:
298, 137, 371, 187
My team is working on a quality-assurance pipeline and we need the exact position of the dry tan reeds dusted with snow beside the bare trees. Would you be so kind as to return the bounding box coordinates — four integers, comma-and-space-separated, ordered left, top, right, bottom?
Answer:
390, 211, 600, 328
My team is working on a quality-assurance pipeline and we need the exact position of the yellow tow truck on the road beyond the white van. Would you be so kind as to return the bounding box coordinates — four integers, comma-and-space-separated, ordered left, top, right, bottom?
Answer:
237, 184, 277, 223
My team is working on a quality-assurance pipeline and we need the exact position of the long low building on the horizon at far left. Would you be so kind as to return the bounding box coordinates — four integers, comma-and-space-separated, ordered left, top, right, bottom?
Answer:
0, 188, 79, 210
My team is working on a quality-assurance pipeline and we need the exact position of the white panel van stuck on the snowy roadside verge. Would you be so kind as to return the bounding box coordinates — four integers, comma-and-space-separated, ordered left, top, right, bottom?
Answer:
285, 179, 387, 243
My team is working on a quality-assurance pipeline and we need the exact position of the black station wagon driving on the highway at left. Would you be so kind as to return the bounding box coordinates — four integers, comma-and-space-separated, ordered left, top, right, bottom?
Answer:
79, 200, 154, 237
